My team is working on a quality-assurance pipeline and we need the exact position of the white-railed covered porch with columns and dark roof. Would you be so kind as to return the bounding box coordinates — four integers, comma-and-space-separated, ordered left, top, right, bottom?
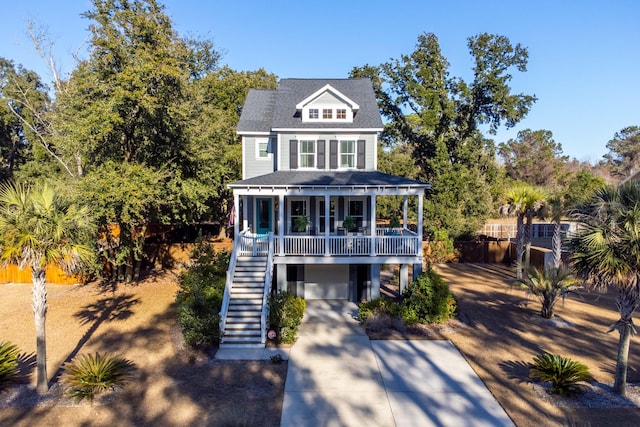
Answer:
230, 171, 429, 257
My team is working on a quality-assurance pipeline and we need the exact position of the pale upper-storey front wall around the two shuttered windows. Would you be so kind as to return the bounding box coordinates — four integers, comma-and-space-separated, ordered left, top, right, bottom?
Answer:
276, 131, 377, 170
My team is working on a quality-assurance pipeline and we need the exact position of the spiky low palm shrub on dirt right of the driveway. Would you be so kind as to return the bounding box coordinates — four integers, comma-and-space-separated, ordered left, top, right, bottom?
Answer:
529, 353, 593, 395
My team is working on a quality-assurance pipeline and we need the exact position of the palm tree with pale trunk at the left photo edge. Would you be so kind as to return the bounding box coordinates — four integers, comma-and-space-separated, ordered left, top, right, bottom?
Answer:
0, 184, 93, 393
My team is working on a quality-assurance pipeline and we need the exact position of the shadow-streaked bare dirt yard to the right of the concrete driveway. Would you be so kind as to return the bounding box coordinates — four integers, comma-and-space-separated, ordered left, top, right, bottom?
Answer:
436, 264, 640, 426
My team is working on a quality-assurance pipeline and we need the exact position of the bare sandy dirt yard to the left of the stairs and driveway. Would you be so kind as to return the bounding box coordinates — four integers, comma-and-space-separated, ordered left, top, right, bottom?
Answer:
0, 273, 287, 426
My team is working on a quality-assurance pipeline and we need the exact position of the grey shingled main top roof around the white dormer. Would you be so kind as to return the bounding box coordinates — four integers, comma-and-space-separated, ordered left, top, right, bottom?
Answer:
237, 78, 383, 134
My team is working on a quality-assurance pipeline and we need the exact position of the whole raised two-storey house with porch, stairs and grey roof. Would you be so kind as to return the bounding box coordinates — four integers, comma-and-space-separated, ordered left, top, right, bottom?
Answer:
220, 79, 429, 346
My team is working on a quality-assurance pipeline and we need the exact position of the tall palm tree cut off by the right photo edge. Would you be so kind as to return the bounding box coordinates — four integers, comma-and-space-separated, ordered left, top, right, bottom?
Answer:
569, 183, 640, 395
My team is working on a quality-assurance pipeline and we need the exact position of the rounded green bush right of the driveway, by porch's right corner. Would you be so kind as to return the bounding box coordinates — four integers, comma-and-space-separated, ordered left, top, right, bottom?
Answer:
402, 269, 457, 325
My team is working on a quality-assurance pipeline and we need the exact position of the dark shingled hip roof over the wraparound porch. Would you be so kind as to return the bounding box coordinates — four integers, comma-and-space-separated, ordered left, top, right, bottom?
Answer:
229, 170, 430, 188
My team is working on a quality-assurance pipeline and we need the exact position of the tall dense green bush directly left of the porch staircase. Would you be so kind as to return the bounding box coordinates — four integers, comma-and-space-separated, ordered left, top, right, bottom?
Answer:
176, 243, 229, 346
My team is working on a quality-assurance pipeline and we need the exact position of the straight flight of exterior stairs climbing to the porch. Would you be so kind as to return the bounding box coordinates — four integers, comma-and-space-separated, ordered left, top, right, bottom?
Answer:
220, 256, 268, 348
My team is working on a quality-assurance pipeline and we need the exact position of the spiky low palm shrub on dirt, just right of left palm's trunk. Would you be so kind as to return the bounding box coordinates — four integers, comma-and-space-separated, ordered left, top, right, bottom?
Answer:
60, 353, 134, 402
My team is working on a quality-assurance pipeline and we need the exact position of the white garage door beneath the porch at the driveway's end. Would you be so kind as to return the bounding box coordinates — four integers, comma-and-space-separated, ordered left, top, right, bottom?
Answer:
304, 264, 349, 299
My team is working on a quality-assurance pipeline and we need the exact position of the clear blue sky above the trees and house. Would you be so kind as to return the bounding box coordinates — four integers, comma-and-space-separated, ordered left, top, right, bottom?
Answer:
0, 0, 640, 162
